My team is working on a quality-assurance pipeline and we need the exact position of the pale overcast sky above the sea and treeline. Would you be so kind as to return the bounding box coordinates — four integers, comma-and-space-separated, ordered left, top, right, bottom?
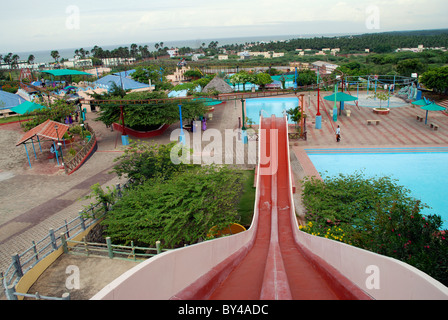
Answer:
0, 0, 448, 53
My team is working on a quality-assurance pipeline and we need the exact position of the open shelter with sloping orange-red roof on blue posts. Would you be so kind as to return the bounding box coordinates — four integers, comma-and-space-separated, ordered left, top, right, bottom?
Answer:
16, 120, 69, 168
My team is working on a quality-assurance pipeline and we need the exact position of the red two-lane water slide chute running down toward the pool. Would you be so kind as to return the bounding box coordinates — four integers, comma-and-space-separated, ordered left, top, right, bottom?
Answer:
176, 116, 369, 300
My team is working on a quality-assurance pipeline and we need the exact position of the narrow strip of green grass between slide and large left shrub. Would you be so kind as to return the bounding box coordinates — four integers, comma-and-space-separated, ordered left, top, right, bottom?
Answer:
238, 170, 255, 229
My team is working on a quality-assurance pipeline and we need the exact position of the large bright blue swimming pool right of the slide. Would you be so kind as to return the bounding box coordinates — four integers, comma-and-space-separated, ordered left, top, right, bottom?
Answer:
305, 148, 448, 228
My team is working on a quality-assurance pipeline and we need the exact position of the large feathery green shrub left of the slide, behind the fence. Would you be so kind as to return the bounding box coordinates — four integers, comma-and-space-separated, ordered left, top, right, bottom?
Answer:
103, 167, 243, 248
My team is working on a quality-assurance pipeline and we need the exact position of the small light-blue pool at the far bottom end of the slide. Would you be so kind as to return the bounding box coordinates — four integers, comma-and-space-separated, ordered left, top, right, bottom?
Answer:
246, 97, 299, 124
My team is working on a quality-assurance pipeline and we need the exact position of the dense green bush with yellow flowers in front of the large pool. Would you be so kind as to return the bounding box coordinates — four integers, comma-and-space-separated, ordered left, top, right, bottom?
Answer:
300, 172, 448, 285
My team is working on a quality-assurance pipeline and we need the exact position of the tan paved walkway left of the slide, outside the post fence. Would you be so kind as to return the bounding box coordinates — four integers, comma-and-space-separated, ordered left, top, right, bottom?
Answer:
0, 98, 245, 299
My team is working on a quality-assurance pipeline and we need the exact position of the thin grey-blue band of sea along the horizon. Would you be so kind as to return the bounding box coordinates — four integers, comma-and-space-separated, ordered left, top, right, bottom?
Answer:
0, 34, 356, 63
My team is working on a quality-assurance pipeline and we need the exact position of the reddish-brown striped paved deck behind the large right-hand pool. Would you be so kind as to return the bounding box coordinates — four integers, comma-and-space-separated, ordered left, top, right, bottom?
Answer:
290, 92, 448, 176
